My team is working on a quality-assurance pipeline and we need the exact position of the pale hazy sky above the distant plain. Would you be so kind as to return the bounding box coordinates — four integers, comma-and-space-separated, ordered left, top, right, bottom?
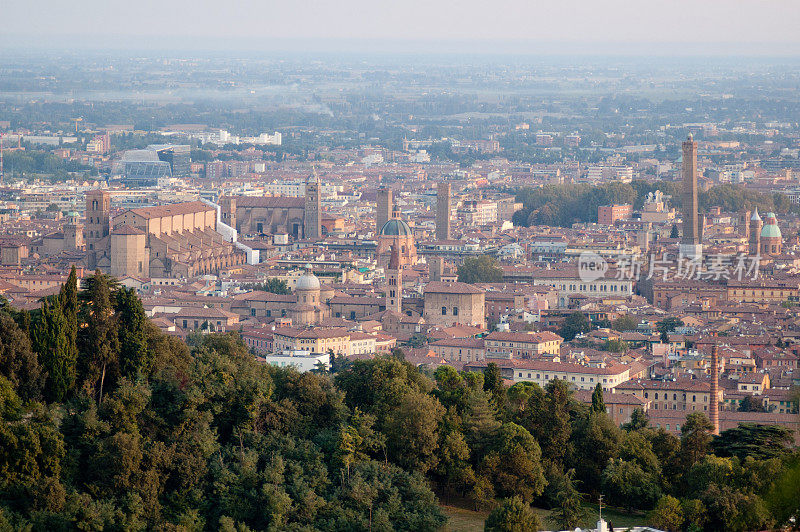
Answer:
0, 0, 800, 54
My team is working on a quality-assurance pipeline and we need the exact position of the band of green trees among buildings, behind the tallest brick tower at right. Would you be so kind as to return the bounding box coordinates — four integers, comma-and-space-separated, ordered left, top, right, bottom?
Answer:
513, 181, 797, 227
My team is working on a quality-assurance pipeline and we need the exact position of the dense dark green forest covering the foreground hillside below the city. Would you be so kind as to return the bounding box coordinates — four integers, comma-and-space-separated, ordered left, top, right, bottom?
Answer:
0, 271, 800, 531
